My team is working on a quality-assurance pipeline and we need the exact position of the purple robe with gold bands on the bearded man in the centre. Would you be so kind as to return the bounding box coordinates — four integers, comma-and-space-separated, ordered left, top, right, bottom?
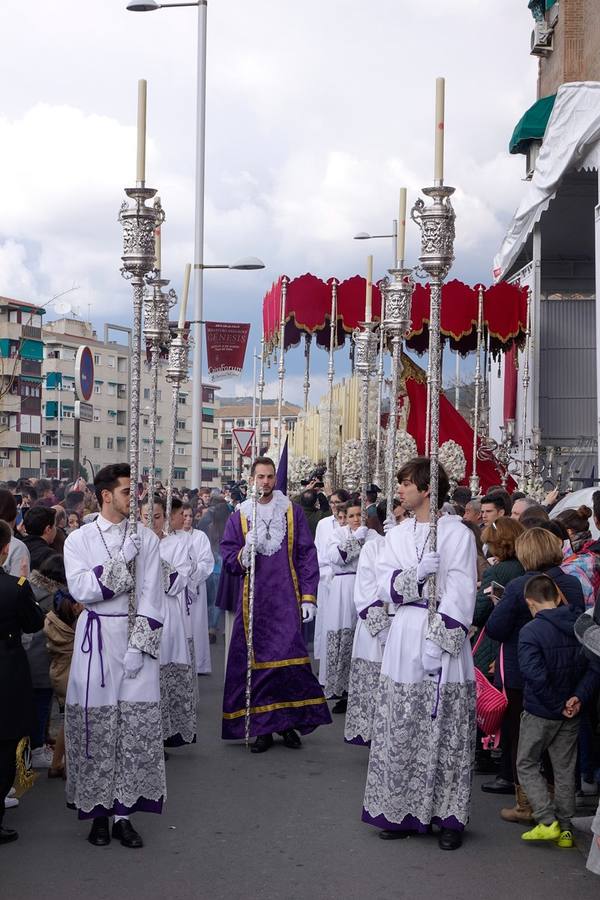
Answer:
221, 504, 331, 740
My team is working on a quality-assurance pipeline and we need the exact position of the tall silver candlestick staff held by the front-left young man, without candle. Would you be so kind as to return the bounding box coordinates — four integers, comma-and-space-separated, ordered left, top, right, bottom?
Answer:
118, 181, 165, 630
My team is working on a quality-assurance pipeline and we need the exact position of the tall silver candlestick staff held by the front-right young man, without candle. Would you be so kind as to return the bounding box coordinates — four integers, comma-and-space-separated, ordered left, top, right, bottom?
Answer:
411, 181, 455, 613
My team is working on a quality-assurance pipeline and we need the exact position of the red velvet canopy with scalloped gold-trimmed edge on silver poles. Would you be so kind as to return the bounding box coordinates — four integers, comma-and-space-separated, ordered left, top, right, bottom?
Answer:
263, 273, 527, 354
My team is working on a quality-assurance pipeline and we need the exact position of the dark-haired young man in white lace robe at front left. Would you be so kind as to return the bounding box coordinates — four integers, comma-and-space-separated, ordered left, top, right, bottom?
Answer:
64, 463, 166, 848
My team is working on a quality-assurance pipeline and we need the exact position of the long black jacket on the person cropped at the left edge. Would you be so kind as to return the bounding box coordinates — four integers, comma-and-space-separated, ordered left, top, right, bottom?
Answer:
0, 568, 44, 741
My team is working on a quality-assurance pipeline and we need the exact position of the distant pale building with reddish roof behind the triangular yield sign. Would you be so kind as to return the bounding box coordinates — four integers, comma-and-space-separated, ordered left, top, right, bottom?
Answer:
215, 397, 301, 482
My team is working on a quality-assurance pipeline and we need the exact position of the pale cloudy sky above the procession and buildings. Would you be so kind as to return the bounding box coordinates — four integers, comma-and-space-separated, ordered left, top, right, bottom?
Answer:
0, 0, 537, 402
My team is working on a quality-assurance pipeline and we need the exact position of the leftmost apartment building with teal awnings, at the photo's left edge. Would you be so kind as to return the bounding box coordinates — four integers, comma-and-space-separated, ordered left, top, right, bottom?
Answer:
0, 297, 45, 481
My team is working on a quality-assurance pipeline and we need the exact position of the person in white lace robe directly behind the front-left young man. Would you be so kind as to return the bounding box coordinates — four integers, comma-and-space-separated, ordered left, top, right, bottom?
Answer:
141, 497, 197, 747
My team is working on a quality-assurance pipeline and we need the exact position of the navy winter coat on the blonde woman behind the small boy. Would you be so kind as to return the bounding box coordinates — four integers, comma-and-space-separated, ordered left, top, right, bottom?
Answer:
486, 566, 584, 690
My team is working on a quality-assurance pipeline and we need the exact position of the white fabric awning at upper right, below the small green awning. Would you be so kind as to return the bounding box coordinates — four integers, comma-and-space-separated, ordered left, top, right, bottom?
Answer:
494, 81, 600, 281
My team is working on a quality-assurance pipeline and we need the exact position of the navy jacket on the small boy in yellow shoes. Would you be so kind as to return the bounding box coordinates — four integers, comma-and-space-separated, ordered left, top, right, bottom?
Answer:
519, 606, 600, 720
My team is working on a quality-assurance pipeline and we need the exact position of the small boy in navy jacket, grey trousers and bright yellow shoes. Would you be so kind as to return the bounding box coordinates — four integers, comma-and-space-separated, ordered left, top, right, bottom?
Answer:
517, 575, 600, 847
